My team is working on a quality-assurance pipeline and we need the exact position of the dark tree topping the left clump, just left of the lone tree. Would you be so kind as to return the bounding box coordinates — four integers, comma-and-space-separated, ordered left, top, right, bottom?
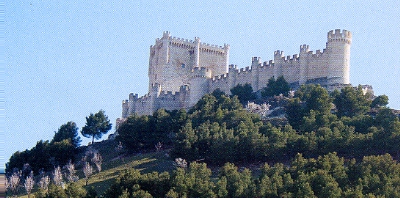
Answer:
51, 122, 82, 148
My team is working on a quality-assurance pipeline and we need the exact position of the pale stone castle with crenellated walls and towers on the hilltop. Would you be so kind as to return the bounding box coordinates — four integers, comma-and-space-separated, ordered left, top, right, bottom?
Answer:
117, 29, 352, 120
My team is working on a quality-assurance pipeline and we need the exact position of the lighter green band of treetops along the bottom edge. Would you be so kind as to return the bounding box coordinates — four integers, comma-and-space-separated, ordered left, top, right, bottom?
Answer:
104, 153, 400, 198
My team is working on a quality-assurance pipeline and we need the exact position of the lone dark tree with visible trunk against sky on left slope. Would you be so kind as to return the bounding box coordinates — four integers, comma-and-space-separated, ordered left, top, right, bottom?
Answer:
81, 110, 111, 144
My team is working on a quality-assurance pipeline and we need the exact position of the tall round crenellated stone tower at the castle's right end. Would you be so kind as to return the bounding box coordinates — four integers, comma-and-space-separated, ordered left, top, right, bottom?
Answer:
326, 29, 352, 84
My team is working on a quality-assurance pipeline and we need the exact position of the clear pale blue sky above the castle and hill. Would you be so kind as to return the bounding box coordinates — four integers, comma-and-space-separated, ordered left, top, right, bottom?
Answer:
0, 0, 400, 168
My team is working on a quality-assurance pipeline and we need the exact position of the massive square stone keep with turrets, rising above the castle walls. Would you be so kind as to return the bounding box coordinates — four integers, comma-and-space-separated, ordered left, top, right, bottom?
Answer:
149, 32, 229, 92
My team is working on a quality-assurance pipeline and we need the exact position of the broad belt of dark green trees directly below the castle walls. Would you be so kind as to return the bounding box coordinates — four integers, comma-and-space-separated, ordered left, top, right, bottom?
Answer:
117, 85, 400, 165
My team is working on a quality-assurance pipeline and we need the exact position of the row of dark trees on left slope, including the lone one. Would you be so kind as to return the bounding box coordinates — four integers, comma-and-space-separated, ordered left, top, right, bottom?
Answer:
6, 110, 111, 177
